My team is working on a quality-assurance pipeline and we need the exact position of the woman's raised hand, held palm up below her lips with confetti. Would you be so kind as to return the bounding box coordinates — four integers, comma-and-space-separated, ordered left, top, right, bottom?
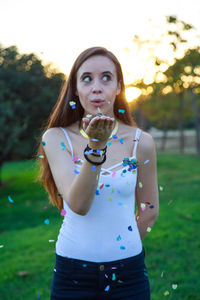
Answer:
82, 116, 115, 149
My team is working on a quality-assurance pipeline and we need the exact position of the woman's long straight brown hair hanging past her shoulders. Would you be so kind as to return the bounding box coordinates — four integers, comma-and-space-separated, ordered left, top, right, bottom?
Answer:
37, 47, 136, 209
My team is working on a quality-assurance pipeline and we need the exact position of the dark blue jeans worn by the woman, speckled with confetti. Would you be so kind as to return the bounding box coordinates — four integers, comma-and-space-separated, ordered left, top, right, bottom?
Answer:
51, 248, 150, 300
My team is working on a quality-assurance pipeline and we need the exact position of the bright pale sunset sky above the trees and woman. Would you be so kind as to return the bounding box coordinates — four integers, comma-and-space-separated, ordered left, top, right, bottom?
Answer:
0, 0, 200, 101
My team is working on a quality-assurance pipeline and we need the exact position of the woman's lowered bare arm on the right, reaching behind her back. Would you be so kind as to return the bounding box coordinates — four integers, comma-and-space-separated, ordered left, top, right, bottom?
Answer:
136, 131, 159, 239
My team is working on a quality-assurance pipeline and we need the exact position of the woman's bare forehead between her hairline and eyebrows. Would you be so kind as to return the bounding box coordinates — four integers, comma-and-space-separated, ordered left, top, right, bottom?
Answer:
77, 55, 116, 75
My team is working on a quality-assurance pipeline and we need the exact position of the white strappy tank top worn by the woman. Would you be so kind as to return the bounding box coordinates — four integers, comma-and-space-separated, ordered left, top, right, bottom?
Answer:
56, 127, 142, 262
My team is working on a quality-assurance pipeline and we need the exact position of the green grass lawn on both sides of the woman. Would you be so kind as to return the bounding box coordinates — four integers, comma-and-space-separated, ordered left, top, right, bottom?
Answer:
0, 154, 200, 300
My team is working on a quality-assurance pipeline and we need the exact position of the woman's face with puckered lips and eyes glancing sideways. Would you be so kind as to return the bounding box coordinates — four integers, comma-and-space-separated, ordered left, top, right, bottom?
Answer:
76, 55, 121, 117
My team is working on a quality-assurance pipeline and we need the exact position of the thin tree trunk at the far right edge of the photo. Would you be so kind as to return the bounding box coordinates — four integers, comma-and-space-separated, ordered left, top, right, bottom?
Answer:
191, 90, 200, 156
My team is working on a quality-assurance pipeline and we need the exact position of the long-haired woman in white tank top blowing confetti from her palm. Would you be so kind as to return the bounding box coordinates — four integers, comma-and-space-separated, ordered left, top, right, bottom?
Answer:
37, 47, 158, 300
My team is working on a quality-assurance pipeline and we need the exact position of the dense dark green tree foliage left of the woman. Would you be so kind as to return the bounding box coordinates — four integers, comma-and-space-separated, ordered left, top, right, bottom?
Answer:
0, 45, 65, 165
